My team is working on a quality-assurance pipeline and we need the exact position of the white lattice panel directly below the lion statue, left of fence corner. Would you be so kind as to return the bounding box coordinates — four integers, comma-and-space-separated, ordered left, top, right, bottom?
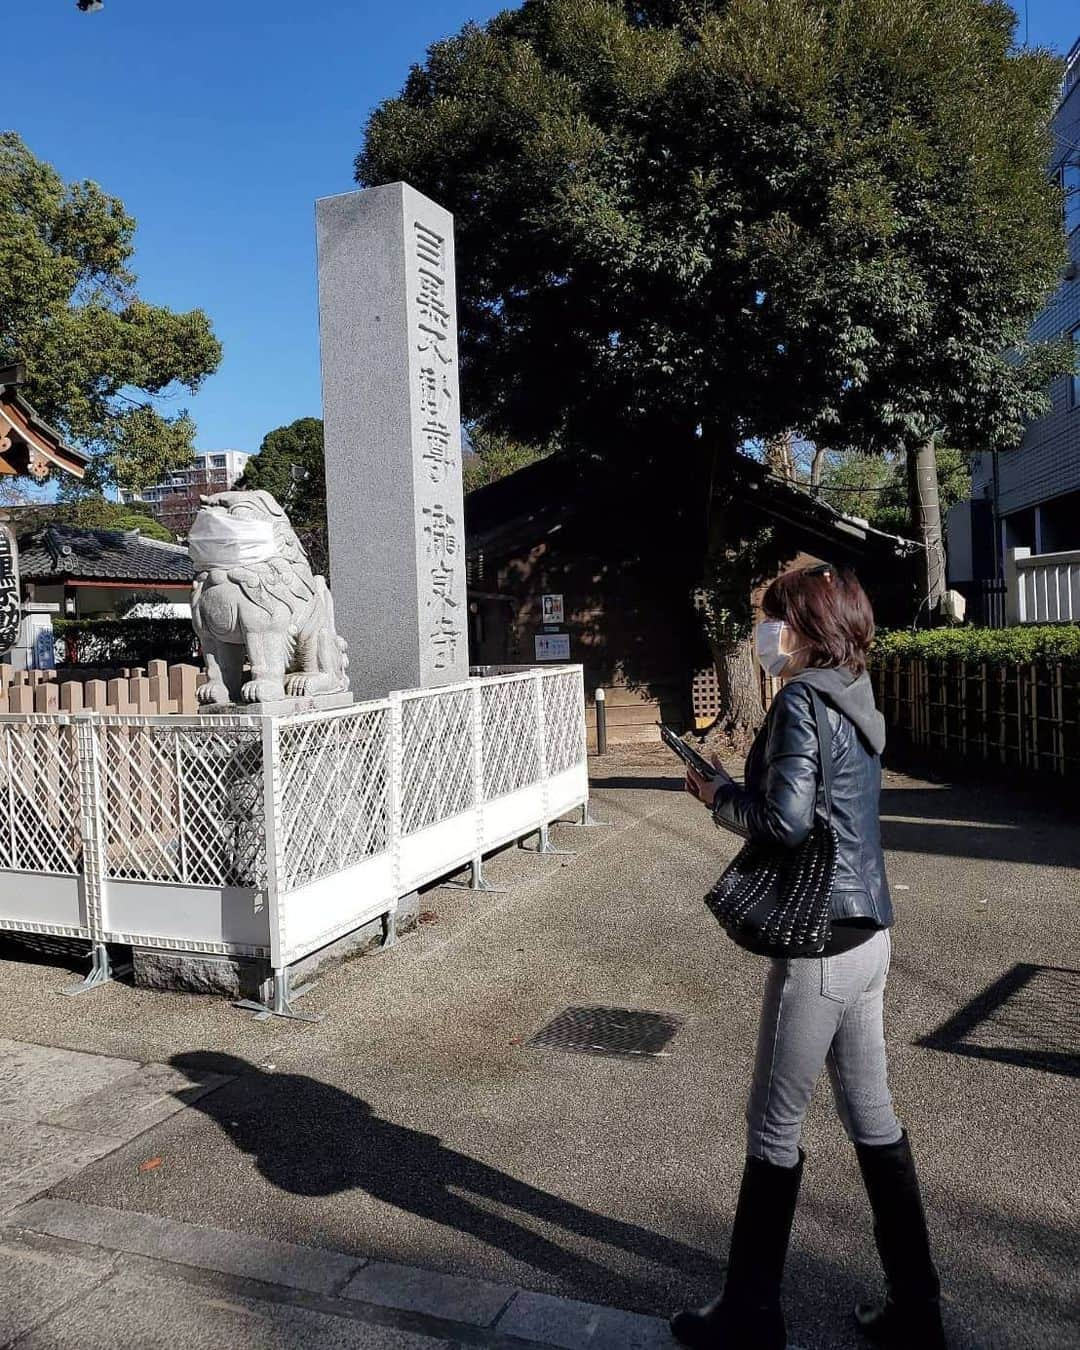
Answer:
99, 722, 266, 887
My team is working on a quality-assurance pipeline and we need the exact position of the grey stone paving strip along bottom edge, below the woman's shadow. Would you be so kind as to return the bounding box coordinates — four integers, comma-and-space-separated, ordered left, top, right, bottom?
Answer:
0, 1199, 675, 1350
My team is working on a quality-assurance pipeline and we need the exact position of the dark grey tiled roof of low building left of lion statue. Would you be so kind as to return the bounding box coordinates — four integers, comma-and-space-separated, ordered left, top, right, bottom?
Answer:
19, 525, 194, 582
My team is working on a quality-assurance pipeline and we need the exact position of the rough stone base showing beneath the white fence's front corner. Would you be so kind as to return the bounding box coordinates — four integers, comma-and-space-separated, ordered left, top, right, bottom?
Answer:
131, 891, 420, 1002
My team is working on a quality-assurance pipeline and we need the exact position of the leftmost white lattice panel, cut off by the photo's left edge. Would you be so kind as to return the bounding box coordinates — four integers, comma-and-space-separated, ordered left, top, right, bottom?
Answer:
0, 722, 82, 884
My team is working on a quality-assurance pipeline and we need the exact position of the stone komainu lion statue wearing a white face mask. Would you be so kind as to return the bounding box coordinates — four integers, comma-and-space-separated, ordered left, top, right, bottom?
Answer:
188, 491, 348, 703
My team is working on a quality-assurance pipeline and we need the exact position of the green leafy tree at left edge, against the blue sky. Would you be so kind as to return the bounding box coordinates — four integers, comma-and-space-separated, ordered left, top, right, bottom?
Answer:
0, 132, 221, 490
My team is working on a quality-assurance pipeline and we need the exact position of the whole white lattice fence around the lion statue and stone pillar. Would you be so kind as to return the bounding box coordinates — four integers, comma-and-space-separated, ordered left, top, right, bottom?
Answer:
0, 667, 589, 1003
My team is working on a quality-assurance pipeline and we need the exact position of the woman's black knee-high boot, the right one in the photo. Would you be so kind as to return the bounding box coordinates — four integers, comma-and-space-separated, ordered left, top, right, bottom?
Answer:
855, 1133, 945, 1350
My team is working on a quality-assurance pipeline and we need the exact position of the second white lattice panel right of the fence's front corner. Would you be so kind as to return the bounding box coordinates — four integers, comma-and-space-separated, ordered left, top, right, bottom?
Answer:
401, 690, 477, 834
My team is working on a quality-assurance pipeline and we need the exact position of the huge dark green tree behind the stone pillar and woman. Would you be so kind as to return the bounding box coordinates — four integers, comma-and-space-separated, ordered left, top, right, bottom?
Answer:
356, 0, 1064, 734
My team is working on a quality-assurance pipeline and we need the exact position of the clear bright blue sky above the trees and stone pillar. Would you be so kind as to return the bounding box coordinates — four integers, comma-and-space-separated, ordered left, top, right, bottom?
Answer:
0, 0, 1080, 450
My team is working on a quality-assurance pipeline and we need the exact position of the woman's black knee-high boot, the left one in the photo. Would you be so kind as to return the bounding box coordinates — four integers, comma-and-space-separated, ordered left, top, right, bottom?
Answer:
671, 1152, 803, 1350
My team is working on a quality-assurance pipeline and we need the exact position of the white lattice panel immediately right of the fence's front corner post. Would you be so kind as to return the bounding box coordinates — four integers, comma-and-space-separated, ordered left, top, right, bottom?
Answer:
278, 707, 390, 890
